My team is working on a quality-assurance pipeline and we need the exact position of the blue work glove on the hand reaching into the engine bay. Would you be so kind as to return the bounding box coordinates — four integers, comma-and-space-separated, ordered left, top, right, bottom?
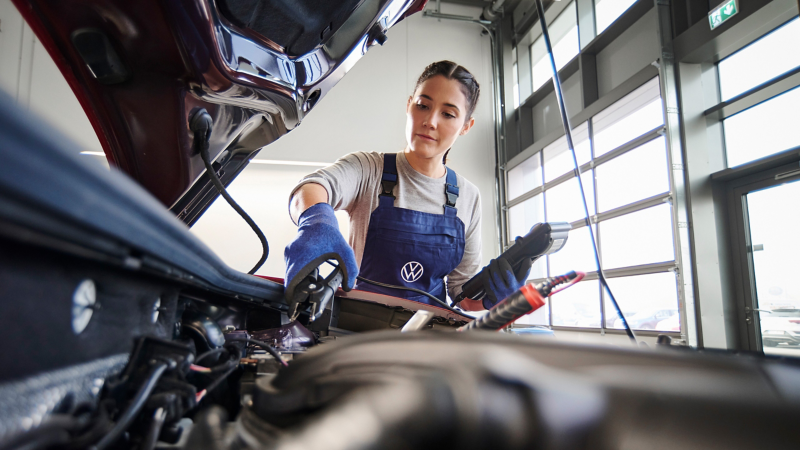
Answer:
283, 203, 358, 301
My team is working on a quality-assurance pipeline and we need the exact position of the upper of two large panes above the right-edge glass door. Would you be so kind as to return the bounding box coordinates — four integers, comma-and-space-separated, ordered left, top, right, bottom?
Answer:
719, 19, 800, 102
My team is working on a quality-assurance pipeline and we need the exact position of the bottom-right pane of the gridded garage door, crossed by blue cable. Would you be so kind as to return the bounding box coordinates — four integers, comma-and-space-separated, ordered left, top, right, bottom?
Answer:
608, 272, 680, 331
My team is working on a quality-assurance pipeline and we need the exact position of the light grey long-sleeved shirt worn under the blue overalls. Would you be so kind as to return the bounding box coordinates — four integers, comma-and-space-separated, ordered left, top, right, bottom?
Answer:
289, 152, 481, 298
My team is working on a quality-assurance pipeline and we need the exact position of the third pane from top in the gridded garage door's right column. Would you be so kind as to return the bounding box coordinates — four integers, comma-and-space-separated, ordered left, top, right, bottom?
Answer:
599, 203, 675, 269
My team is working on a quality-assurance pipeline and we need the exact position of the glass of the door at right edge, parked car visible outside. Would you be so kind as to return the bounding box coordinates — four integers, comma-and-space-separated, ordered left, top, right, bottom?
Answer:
744, 178, 800, 357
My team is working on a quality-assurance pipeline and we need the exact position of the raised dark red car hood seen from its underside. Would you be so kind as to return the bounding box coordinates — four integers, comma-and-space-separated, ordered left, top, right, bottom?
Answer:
12, 0, 427, 225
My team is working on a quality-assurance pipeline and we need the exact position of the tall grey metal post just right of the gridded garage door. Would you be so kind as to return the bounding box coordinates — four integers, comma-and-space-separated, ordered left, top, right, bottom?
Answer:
654, 0, 697, 347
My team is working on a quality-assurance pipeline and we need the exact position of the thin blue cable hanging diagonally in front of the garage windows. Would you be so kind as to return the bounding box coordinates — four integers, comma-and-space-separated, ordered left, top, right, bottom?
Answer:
536, 0, 636, 343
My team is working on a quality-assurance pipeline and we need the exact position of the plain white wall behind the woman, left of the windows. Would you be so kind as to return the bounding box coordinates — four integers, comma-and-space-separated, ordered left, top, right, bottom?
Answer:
193, 4, 498, 277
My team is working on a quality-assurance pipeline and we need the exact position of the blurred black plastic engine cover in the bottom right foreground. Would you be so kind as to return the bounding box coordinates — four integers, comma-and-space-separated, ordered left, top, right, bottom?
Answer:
248, 331, 800, 450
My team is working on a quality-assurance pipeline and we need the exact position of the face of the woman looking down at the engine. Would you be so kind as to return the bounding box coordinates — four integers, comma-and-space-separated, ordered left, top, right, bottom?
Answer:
406, 75, 475, 160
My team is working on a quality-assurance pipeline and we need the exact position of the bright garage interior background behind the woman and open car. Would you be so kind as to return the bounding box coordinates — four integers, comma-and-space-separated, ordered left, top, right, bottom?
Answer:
0, 0, 800, 356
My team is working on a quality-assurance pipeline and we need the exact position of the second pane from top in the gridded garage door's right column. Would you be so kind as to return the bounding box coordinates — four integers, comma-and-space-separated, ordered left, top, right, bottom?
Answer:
595, 137, 669, 212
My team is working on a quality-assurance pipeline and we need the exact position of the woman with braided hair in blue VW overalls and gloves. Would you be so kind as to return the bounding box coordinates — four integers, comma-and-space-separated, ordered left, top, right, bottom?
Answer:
285, 61, 530, 310
